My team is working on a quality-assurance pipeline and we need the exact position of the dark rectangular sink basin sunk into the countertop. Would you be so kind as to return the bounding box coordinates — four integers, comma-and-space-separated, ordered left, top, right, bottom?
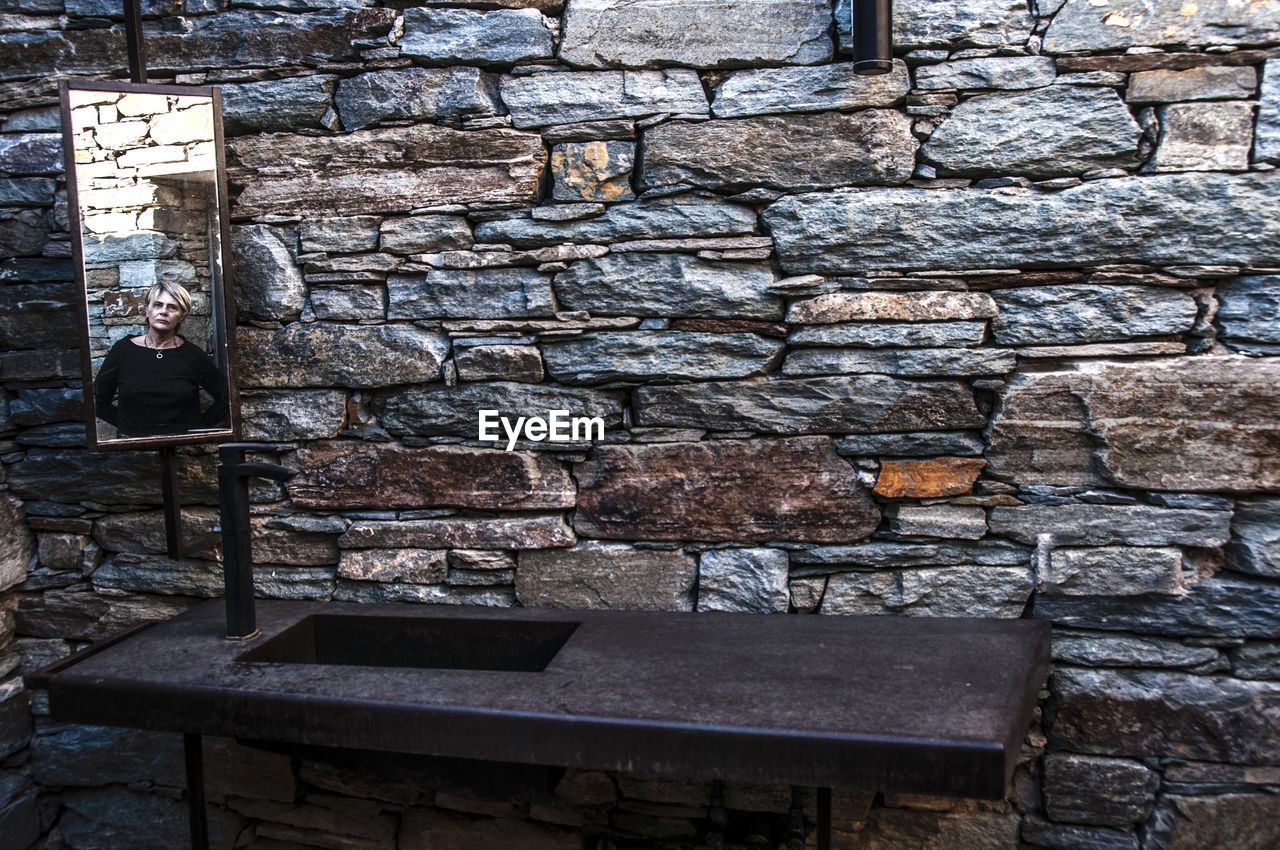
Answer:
236, 614, 579, 673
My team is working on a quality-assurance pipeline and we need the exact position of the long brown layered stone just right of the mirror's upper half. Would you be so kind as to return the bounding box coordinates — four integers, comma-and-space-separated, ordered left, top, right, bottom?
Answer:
227, 124, 545, 218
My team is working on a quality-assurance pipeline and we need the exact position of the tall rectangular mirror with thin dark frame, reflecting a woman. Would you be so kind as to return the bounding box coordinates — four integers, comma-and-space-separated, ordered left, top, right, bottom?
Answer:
60, 81, 239, 449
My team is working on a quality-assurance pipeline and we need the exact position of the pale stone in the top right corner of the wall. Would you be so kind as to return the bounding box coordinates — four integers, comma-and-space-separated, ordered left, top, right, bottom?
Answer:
1044, 0, 1280, 54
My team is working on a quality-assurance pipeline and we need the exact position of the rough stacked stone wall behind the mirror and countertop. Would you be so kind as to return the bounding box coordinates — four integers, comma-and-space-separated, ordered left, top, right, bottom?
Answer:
0, 0, 1280, 850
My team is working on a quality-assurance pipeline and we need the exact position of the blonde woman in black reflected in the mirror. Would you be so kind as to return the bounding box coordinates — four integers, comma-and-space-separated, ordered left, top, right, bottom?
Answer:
93, 283, 227, 437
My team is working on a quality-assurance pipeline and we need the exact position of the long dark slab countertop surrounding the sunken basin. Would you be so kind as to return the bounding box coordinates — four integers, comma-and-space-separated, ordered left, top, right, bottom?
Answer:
37, 600, 1050, 799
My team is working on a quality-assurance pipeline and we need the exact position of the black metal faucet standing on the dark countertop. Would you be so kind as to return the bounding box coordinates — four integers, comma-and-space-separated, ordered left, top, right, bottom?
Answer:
218, 443, 296, 640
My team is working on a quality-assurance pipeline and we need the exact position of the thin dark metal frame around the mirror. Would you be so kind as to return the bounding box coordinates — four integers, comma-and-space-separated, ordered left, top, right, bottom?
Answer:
58, 79, 241, 452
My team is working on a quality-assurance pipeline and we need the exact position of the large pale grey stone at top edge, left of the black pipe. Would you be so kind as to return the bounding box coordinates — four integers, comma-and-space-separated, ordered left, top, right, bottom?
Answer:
559, 0, 832, 68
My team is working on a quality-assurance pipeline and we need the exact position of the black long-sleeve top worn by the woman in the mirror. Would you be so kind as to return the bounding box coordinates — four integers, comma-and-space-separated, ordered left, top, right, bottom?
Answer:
93, 338, 228, 437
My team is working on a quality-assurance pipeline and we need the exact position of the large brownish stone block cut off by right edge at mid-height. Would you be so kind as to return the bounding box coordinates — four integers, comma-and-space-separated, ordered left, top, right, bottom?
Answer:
987, 357, 1280, 493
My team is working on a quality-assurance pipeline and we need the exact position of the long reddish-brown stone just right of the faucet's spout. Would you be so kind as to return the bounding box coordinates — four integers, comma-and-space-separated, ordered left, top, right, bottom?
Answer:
288, 443, 575, 511
